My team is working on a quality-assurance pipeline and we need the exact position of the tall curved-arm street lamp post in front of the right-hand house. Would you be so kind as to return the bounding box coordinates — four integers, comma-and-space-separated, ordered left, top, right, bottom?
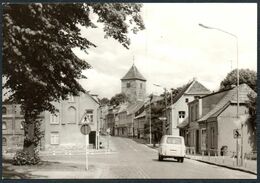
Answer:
199, 24, 243, 165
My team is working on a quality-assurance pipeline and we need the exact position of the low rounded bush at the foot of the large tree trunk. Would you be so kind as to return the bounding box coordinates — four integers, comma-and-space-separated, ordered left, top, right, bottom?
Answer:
12, 150, 40, 165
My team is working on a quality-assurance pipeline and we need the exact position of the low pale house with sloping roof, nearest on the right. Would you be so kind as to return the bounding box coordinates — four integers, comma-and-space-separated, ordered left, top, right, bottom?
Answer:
186, 84, 256, 155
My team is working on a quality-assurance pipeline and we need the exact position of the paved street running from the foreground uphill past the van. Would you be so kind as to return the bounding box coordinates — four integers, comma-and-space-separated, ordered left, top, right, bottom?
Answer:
41, 137, 256, 179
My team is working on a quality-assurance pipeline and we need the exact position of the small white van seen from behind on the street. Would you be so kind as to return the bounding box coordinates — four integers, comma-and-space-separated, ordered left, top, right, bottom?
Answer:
158, 135, 186, 163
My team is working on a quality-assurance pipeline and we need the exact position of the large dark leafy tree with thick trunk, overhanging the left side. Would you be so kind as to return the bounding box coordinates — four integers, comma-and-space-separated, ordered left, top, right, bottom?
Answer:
3, 3, 144, 164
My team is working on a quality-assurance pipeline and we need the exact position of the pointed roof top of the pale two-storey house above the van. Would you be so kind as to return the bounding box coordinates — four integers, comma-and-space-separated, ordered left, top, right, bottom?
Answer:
172, 79, 210, 104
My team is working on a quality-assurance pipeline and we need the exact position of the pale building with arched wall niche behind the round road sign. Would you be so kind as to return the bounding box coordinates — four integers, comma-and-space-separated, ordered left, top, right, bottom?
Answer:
44, 93, 100, 149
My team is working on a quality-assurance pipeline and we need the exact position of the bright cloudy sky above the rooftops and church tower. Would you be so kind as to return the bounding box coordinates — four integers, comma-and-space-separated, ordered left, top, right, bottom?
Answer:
73, 3, 257, 99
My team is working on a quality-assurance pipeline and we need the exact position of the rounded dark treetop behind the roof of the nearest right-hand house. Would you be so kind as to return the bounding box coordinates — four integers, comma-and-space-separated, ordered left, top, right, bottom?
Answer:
220, 69, 257, 92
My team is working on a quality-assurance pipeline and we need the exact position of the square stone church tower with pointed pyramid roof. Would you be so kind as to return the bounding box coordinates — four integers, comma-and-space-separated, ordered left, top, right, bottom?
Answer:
121, 64, 146, 102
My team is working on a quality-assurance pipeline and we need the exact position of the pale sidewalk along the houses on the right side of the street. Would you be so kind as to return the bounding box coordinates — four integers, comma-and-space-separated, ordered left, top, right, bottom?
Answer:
141, 144, 257, 175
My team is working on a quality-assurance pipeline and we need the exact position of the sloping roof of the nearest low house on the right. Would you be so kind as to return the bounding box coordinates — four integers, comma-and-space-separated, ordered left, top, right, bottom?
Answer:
198, 84, 255, 122
